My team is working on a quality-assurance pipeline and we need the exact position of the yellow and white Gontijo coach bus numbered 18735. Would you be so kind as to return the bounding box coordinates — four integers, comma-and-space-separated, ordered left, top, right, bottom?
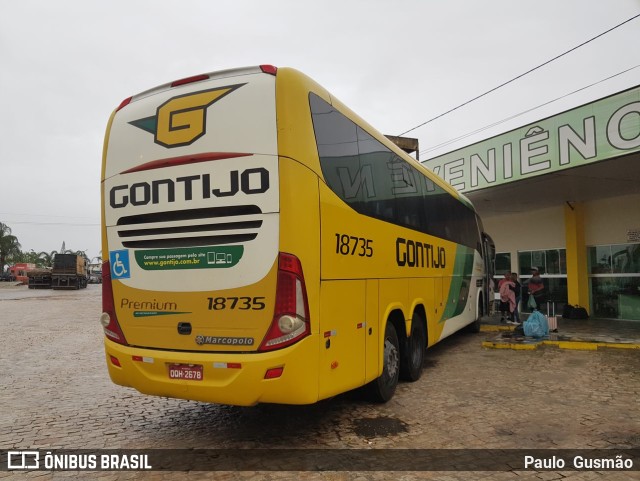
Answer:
101, 66, 492, 405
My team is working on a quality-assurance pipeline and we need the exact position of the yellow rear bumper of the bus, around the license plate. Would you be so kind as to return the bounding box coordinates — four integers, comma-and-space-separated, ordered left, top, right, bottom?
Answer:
105, 335, 318, 406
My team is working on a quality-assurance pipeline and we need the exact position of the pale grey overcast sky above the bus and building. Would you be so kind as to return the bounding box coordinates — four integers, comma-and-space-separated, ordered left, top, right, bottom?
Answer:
0, 0, 640, 257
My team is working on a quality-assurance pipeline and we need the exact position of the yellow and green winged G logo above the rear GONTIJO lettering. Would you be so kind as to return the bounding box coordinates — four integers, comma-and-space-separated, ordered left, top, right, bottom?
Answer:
129, 84, 246, 149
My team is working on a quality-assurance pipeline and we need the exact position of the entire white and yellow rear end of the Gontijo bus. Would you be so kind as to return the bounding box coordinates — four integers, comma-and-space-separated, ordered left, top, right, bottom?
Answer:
101, 66, 318, 405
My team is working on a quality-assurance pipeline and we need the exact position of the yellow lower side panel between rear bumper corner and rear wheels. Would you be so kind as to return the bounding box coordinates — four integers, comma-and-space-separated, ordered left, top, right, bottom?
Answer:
319, 280, 367, 399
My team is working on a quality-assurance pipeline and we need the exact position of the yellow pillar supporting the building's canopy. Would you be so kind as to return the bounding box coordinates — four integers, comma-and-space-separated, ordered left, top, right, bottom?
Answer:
564, 202, 589, 310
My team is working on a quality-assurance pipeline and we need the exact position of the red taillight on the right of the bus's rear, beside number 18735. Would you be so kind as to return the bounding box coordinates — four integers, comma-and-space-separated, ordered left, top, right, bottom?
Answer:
259, 252, 311, 351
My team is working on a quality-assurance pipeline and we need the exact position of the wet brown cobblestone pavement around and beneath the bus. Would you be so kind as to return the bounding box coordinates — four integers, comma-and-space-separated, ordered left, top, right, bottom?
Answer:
0, 285, 640, 481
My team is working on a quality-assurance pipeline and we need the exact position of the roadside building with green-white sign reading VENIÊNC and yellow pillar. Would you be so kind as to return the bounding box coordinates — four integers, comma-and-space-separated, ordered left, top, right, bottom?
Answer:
423, 85, 640, 321
